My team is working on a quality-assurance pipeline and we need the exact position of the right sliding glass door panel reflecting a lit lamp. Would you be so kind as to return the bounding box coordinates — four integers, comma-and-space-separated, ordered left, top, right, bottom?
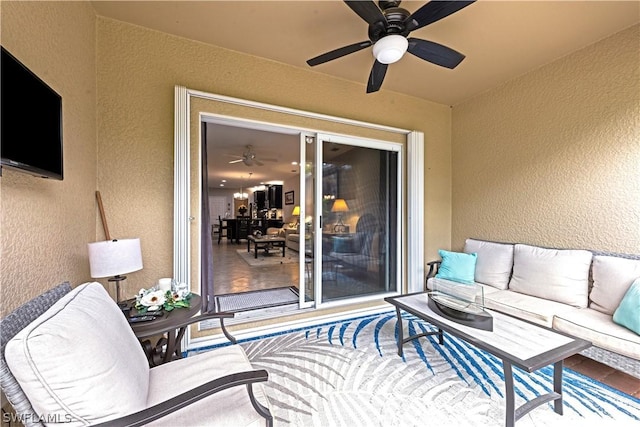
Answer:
314, 135, 399, 303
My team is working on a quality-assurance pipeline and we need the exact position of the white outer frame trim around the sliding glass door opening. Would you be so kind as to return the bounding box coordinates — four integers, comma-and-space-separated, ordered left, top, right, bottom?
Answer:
173, 85, 425, 348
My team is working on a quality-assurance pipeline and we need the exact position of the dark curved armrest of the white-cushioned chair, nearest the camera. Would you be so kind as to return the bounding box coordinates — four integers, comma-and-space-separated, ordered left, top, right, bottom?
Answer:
94, 369, 273, 427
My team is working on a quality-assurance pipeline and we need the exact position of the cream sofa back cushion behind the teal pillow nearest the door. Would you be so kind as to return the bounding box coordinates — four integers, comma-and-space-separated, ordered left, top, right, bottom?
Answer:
464, 239, 513, 289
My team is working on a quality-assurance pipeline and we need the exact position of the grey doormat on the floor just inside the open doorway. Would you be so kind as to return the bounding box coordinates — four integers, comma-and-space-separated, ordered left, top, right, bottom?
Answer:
216, 286, 300, 313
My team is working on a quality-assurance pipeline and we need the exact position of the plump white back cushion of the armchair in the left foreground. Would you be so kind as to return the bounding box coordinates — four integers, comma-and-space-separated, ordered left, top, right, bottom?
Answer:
5, 282, 149, 426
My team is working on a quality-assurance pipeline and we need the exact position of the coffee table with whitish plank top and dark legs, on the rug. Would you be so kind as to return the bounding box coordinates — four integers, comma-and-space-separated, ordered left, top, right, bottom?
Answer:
385, 292, 591, 427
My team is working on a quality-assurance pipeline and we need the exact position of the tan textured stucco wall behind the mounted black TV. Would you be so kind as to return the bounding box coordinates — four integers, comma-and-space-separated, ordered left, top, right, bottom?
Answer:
0, 2, 96, 316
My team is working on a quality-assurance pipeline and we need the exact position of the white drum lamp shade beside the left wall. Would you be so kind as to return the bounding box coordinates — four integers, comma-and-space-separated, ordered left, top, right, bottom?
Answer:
88, 239, 142, 279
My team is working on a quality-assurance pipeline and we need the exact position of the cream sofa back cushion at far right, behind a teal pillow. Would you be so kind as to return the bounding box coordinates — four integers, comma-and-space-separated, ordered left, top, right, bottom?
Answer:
589, 255, 640, 315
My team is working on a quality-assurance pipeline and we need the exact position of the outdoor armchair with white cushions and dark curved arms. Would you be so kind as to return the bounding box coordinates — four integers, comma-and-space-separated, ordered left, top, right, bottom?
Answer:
0, 282, 273, 427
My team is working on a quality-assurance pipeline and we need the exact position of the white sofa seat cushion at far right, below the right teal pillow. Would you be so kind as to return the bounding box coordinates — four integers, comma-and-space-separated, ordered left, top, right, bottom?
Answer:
553, 308, 640, 364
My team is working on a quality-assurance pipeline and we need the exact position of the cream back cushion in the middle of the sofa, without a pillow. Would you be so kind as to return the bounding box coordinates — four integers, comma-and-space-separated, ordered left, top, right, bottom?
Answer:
509, 244, 593, 308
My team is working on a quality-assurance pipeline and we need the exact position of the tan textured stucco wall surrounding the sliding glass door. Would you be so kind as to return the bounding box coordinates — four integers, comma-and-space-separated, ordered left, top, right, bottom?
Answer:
97, 18, 451, 300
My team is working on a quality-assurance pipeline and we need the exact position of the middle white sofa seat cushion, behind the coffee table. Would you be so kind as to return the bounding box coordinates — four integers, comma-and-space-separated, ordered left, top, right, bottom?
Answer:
484, 290, 573, 328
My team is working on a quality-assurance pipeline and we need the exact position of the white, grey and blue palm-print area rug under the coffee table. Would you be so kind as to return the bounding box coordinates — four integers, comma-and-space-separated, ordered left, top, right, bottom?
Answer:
191, 311, 640, 427
